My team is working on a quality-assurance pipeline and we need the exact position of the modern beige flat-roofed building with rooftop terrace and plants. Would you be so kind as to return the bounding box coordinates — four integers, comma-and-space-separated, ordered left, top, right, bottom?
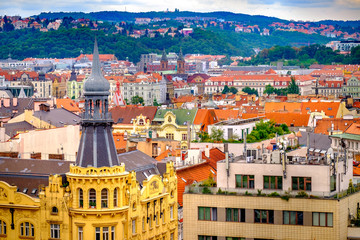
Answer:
183, 140, 360, 240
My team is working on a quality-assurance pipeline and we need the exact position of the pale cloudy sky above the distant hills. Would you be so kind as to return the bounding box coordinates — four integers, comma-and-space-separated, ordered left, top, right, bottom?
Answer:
0, 0, 360, 21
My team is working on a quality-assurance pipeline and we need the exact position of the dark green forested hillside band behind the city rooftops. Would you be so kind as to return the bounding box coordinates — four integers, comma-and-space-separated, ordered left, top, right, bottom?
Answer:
0, 27, 330, 62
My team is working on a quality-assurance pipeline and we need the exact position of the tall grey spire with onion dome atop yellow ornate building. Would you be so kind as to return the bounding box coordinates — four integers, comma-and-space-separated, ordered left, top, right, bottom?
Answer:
76, 39, 120, 167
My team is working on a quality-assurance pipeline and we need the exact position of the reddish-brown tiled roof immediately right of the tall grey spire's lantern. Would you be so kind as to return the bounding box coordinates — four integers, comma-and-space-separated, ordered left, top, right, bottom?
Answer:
109, 105, 157, 124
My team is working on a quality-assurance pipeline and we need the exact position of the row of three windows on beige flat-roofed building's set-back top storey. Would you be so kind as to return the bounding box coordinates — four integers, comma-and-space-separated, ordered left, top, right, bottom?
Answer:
235, 175, 311, 191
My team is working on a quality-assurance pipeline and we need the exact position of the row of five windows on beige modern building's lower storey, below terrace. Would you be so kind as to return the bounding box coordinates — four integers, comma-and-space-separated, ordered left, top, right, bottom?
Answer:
198, 207, 333, 227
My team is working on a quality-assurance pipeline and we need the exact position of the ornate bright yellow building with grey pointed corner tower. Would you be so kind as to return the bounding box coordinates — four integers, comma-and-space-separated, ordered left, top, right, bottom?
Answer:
0, 38, 178, 240
